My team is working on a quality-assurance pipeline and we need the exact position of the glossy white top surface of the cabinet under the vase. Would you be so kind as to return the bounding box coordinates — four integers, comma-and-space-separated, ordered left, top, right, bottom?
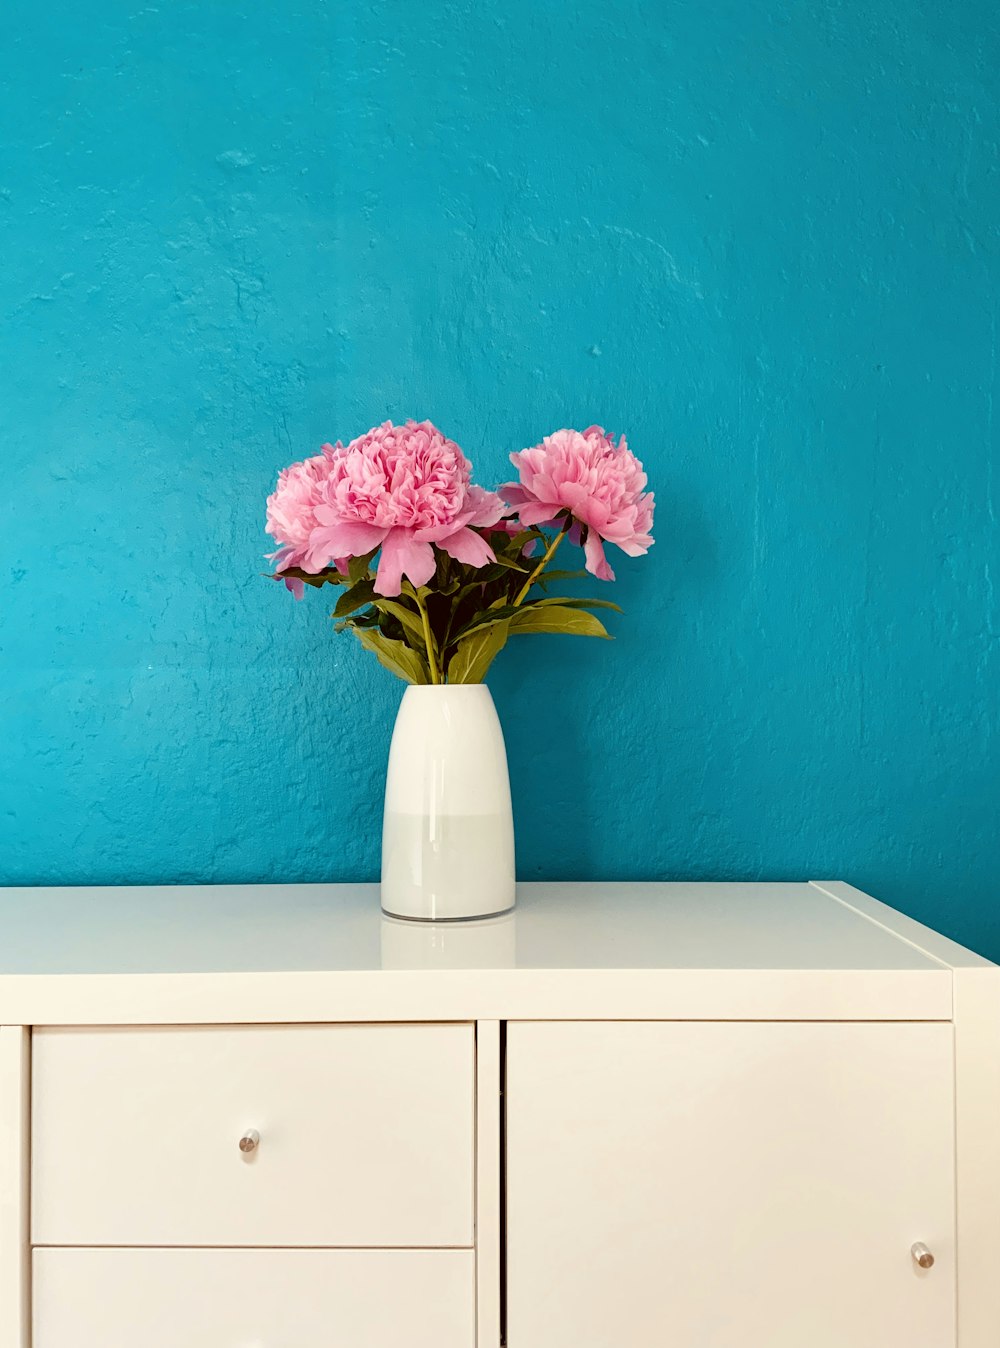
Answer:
0, 882, 985, 977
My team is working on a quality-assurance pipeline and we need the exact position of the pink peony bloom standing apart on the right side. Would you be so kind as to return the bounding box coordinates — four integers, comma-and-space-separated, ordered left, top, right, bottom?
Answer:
501, 426, 654, 581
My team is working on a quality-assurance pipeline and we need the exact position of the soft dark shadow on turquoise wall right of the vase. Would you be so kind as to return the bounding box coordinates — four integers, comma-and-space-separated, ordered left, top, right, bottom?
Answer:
501, 480, 720, 880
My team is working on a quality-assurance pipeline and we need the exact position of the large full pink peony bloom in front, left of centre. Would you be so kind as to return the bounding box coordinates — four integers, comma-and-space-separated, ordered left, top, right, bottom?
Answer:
303, 421, 504, 596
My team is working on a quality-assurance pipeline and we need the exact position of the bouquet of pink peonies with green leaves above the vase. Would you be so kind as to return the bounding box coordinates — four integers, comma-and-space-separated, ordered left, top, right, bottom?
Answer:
267, 421, 654, 683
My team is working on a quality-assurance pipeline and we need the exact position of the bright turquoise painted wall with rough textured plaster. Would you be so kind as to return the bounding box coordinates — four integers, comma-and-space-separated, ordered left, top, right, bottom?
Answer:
0, 0, 1000, 958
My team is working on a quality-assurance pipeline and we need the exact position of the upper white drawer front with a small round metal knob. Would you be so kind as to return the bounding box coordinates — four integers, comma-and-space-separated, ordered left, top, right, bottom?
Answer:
31, 1024, 474, 1247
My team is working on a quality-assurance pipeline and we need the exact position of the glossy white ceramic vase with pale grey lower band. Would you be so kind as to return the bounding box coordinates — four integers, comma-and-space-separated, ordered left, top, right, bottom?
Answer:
381, 683, 513, 922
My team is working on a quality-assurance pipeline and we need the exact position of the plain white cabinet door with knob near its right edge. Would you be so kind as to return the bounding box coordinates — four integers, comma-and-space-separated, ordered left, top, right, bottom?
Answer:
507, 1022, 956, 1348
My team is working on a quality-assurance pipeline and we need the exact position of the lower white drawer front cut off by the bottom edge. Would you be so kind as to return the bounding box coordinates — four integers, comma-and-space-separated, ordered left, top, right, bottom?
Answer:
32, 1250, 476, 1348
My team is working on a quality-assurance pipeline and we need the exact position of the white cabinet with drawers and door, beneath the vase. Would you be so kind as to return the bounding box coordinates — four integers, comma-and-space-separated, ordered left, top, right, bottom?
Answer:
0, 883, 1000, 1348
